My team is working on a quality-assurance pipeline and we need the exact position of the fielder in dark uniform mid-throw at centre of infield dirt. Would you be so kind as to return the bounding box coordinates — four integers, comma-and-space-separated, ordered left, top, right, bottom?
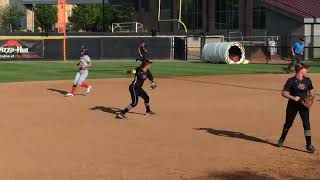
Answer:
116, 60, 156, 119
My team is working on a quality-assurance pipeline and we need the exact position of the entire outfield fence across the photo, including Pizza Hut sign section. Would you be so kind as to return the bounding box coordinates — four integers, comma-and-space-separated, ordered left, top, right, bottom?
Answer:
0, 33, 320, 63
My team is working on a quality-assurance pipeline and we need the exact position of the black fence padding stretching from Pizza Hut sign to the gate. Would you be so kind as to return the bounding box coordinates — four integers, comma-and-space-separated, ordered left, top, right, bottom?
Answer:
0, 36, 172, 60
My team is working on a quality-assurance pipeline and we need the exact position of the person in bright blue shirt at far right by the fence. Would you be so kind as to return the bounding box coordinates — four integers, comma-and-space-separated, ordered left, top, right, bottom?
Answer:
288, 38, 305, 72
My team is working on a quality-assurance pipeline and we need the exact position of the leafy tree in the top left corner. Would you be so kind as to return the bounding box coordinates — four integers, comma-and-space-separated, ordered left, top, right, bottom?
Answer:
0, 2, 25, 32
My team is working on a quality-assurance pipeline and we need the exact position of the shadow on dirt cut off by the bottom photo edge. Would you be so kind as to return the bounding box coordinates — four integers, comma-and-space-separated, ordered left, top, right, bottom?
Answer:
192, 171, 276, 180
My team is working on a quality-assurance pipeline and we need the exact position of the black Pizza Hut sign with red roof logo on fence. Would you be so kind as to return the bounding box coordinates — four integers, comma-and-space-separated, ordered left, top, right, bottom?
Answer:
0, 40, 43, 59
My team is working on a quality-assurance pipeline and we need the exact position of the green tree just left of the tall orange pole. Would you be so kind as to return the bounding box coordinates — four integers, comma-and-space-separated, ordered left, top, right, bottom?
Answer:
35, 5, 58, 32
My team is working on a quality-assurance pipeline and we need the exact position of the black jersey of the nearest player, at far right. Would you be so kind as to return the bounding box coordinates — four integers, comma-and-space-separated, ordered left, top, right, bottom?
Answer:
283, 76, 313, 98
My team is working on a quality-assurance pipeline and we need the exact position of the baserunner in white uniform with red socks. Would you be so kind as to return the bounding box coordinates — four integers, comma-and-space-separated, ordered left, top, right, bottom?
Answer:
66, 46, 92, 97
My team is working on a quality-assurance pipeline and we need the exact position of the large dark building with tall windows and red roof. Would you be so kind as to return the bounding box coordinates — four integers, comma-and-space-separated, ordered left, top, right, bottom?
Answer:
136, 0, 320, 57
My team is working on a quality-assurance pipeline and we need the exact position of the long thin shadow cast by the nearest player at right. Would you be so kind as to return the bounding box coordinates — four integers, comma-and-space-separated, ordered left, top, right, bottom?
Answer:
194, 128, 306, 152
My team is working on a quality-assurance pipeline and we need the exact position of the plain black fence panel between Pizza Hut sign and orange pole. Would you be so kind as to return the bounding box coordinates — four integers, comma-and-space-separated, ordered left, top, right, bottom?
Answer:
44, 40, 63, 60
